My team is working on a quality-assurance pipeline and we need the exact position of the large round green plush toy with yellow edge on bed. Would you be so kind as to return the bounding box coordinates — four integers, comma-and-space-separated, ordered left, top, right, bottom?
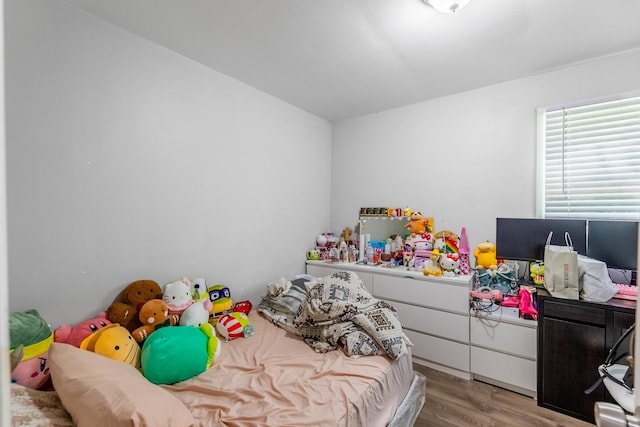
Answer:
141, 323, 220, 384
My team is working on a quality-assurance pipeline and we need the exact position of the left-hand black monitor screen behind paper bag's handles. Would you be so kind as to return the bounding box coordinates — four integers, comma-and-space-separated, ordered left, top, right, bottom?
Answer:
496, 218, 587, 261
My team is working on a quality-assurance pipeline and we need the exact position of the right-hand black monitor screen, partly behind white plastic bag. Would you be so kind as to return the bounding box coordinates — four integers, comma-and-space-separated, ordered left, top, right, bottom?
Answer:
587, 221, 638, 270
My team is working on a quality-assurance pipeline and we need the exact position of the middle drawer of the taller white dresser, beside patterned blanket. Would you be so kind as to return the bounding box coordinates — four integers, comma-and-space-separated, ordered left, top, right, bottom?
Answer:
398, 301, 469, 343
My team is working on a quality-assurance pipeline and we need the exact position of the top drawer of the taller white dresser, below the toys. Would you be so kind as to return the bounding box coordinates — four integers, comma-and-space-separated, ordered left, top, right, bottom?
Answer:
373, 274, 469, 315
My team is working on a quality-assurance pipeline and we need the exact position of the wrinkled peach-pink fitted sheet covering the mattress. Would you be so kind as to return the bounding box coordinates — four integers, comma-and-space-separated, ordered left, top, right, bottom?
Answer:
162, 311, 413, 427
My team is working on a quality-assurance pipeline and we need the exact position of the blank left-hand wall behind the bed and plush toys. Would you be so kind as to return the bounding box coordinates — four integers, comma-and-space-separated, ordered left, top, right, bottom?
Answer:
5, 0, 331, 327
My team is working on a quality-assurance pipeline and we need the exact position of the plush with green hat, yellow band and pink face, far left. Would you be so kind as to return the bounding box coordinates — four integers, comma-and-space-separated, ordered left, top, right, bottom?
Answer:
9, 309, 53, 390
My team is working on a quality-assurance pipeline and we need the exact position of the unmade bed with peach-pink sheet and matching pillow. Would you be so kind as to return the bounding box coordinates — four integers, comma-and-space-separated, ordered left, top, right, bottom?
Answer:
12, 272, 425, 427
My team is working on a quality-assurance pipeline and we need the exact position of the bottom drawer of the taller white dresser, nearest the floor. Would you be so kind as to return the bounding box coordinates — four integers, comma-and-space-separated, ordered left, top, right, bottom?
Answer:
405, 330, 469, 372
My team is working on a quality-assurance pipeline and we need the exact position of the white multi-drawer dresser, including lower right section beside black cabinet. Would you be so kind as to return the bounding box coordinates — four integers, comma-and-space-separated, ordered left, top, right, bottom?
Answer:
307, 261, 537, 397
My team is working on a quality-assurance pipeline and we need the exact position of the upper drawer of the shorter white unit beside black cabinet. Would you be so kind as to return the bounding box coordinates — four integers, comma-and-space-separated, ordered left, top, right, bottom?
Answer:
470, 316, 538, 360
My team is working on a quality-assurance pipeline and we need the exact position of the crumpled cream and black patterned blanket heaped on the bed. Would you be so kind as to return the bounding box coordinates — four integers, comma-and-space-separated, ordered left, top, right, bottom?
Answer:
293, 271, 410, 360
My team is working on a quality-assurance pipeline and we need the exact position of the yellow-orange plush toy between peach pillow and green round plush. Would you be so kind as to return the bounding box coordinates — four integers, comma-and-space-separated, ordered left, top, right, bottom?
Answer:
80, 323, 141, 368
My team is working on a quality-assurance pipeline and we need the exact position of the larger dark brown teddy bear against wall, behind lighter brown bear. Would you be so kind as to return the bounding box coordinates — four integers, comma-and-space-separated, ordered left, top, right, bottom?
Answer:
107, 280, 162, 332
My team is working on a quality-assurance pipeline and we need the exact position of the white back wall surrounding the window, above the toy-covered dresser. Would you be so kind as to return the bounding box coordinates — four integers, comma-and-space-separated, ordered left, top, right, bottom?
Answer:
331, 50, 640, 254
